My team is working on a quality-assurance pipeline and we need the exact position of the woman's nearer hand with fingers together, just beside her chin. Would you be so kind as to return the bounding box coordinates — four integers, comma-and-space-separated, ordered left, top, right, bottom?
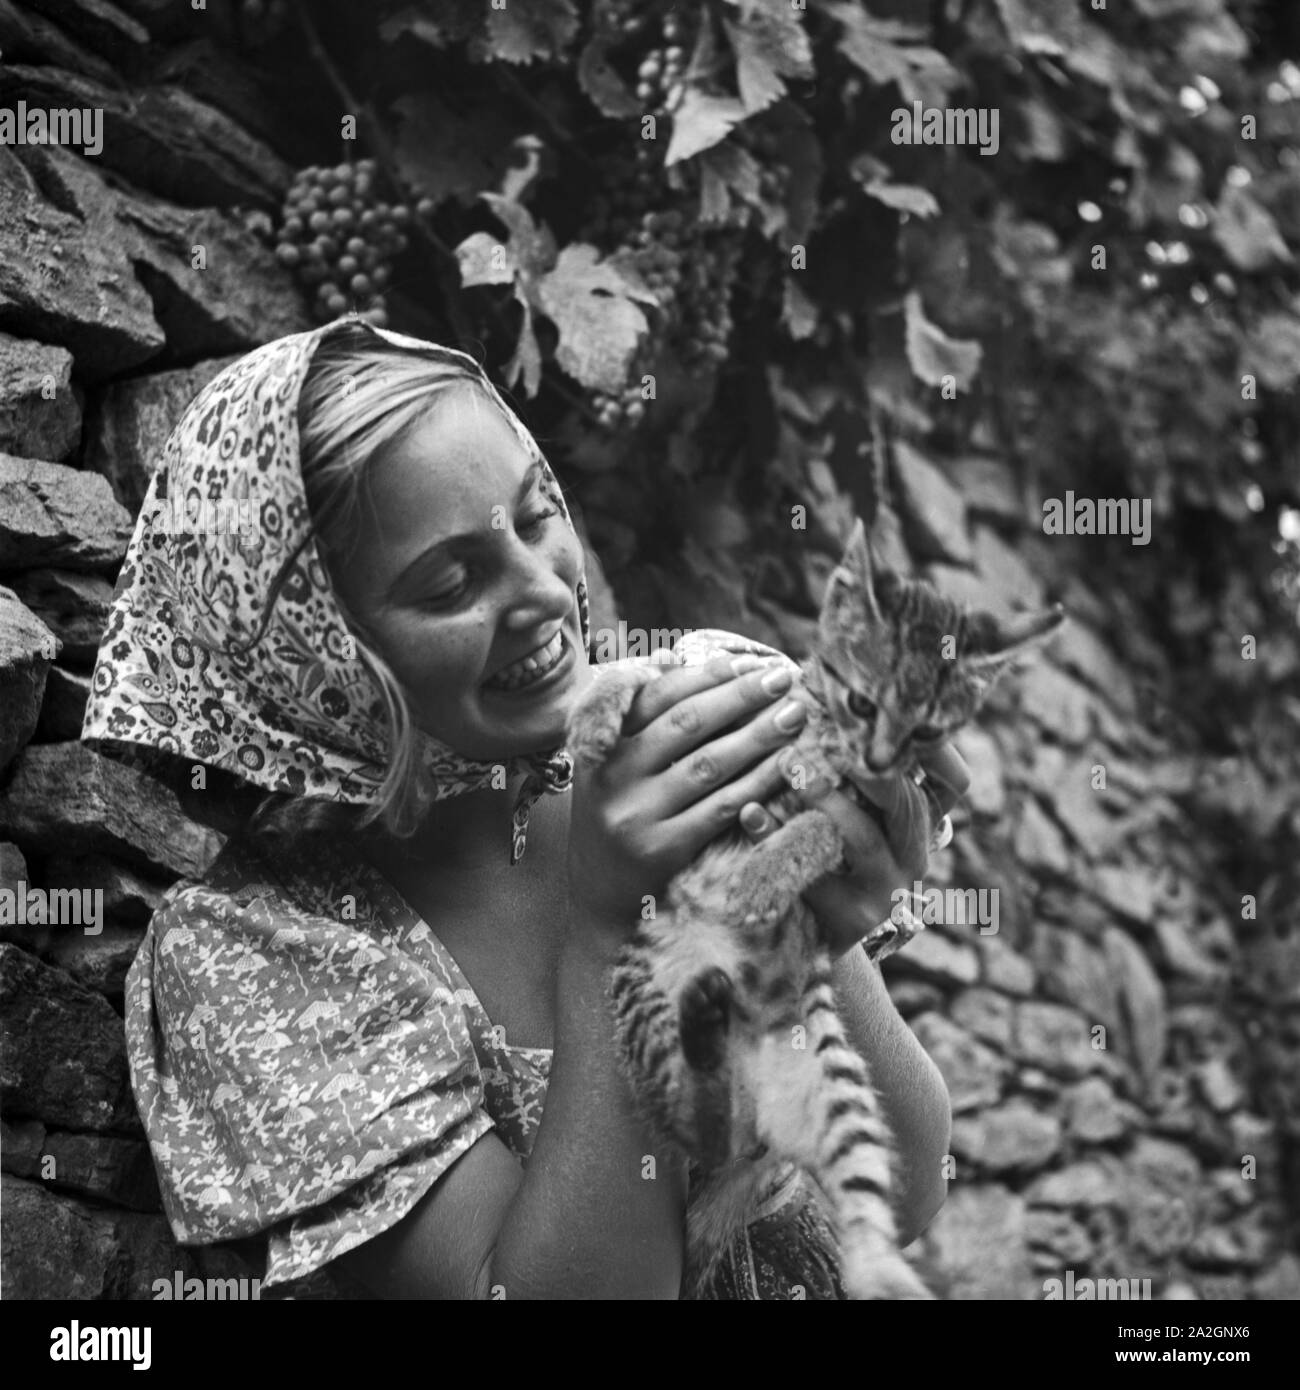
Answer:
569, 656, 808, 941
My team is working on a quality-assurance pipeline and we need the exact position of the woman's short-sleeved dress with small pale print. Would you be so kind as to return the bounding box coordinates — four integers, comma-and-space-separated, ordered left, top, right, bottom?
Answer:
127, 840, 843, 1300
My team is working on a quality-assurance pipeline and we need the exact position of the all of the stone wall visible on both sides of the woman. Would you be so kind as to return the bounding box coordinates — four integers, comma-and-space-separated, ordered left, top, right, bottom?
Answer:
0, 0, 1300, 1298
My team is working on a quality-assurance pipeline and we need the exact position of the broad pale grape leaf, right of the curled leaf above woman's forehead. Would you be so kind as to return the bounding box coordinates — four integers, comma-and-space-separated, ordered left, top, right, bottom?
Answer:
537, 242, 655, 393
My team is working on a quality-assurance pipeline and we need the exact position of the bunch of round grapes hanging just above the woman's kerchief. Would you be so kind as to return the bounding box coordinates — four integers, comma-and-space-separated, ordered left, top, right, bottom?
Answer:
275, 160, 428, 328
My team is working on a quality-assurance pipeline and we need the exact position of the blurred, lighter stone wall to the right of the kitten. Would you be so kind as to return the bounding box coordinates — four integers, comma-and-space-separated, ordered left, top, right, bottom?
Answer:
887, 450, 1300, 1298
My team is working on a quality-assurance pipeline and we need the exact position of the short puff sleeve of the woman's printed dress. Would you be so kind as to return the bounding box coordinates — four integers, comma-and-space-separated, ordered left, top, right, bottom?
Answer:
125, 884, 492, 1284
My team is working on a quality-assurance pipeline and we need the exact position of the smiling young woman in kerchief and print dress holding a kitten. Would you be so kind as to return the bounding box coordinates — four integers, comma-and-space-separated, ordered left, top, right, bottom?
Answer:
83, 320, 966, 1298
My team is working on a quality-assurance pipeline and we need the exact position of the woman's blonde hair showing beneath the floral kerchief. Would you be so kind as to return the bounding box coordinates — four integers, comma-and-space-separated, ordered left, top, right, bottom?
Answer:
230, 322, 520, 837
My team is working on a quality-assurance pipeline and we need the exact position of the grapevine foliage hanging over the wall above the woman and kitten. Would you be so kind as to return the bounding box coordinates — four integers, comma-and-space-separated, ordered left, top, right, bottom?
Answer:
251, 0, 1300, 945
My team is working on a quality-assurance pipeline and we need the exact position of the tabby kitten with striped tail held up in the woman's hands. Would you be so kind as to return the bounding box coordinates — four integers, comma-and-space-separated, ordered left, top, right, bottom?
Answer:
569, 521, 1064, 1298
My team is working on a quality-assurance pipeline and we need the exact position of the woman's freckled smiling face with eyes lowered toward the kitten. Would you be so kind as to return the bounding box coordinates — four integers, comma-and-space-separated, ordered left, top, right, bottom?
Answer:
331, 386, 590, 762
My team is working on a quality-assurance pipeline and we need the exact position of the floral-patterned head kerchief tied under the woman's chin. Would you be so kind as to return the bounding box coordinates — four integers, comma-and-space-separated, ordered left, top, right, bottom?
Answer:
82, 317, 591, 863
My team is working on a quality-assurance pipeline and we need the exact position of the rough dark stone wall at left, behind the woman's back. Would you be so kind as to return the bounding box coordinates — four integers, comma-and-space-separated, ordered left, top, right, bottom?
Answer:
0, 4, 310, 1298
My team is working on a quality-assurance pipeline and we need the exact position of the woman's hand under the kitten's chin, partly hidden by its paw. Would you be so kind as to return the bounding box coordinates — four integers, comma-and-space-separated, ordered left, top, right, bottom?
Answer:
741, 744, 970, 956
